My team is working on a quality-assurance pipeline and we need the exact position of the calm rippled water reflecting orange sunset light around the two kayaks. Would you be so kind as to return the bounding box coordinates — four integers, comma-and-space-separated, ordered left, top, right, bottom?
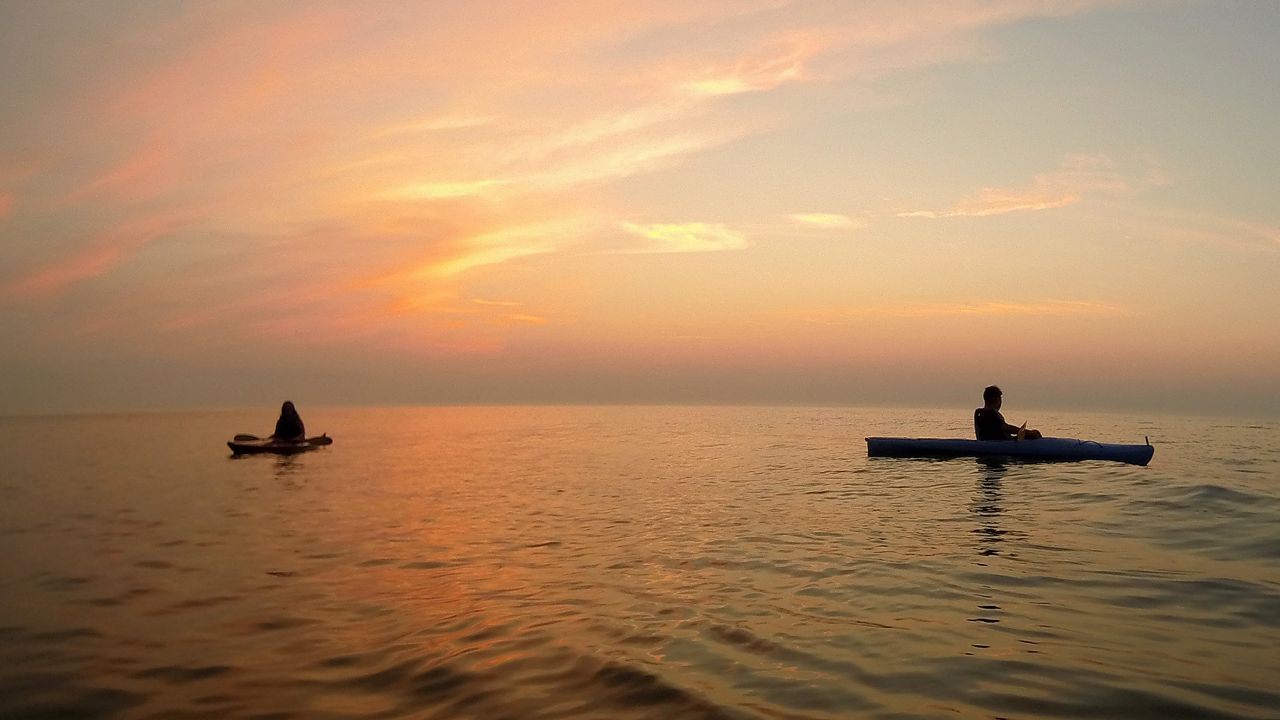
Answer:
0, 405, 1280, 720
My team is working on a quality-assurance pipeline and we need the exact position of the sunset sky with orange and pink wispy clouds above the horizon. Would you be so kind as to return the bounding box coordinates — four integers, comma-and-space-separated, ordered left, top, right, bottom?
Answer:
0, 0, 1280, 418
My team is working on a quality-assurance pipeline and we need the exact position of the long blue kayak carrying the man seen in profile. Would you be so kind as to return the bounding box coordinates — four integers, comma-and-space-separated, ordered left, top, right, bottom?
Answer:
867, 437, 1156, 465
